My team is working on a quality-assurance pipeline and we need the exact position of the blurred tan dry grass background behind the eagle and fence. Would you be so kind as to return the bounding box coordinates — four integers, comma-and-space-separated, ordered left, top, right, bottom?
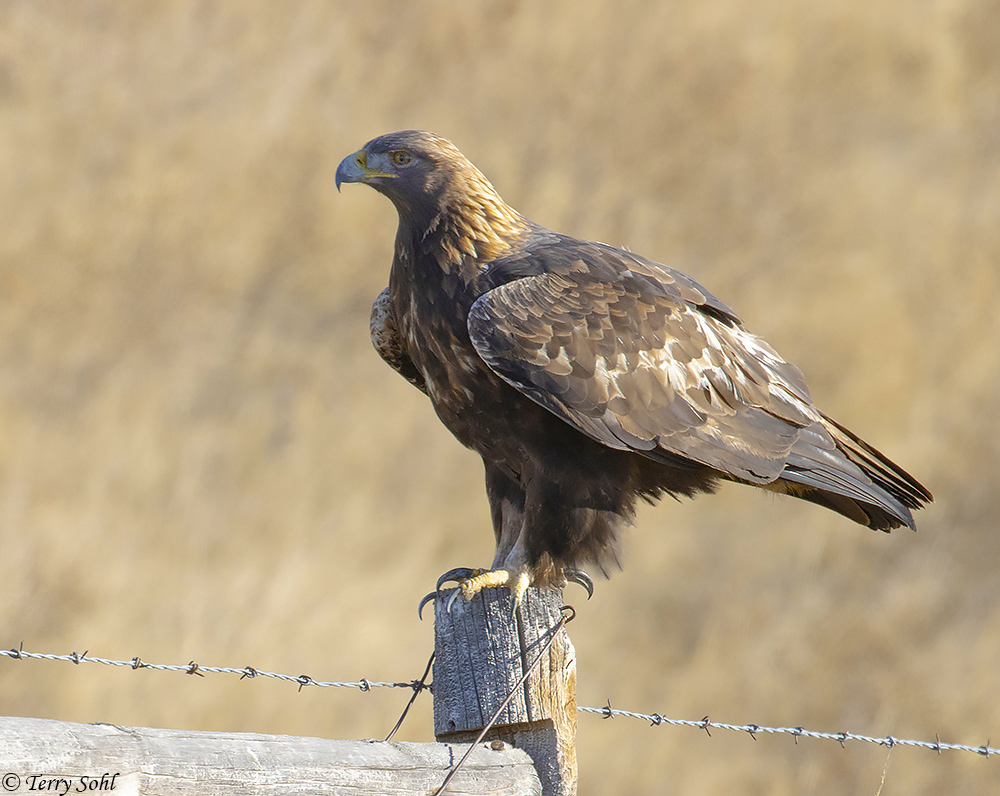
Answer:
0, 0, 1000, 796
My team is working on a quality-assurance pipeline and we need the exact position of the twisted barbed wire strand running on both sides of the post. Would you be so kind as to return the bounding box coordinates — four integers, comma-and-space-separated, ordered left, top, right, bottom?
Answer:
0, 647, 1000, 758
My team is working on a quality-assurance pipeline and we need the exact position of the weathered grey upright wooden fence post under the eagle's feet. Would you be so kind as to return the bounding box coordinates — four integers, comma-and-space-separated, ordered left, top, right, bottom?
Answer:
434, 589, 577, 796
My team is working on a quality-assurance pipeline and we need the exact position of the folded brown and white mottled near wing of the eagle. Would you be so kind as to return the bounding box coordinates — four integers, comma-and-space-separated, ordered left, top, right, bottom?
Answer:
468, 236, 820, 484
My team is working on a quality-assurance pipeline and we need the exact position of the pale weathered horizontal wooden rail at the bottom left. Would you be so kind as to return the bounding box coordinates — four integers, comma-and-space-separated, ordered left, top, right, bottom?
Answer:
0, 718, 542, 796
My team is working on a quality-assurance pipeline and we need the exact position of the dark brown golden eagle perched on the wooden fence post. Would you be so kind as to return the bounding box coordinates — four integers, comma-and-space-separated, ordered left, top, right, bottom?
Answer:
336, 131, 932, 598
